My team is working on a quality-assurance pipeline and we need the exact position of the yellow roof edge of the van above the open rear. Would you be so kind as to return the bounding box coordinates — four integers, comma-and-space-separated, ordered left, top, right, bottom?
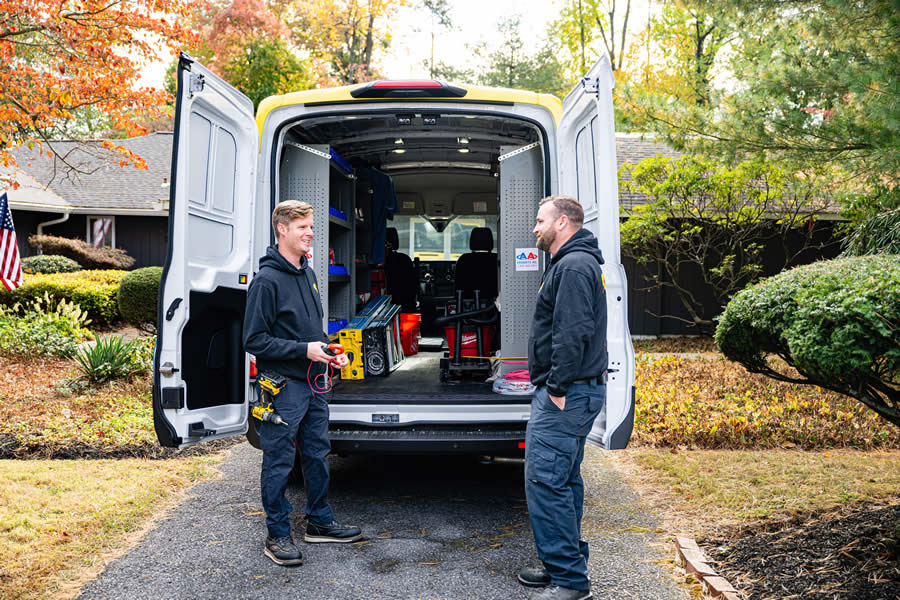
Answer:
256, 84, 562, 134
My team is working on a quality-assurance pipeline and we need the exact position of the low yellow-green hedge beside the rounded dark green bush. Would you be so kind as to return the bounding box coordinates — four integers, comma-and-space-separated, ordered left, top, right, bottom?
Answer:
0, 271, 127, 325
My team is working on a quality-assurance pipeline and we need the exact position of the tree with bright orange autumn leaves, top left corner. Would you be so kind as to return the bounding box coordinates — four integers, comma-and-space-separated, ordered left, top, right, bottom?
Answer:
0, 0, 202, 179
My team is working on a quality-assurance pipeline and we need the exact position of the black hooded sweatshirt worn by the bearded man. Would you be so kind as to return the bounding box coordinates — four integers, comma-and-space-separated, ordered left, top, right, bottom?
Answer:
528, 229, 608, 396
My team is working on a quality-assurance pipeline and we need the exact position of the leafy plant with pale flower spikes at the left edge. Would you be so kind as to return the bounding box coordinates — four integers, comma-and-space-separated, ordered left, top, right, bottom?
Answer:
0, 294, 92, 357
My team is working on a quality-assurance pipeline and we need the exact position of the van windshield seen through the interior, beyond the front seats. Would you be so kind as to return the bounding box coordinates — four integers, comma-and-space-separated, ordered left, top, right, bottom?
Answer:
390, 215, 499, 260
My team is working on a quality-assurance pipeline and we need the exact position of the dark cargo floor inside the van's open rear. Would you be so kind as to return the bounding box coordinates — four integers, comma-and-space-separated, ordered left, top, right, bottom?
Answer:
330, 352, 509, 404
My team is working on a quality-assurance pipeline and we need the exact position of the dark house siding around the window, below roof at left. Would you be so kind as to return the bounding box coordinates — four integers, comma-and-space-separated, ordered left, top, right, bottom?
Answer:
12, 210, 169, 269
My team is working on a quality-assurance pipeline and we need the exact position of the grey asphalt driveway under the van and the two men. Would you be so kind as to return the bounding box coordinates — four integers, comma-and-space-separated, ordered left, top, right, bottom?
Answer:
80, 443, 689, 600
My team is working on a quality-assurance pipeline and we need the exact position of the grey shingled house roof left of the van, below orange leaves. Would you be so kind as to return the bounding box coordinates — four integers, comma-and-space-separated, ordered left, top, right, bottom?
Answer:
8, 132, 174, 216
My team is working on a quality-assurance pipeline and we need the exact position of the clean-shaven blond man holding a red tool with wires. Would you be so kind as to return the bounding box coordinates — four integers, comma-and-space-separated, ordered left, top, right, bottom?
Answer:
244, 200, 362, 565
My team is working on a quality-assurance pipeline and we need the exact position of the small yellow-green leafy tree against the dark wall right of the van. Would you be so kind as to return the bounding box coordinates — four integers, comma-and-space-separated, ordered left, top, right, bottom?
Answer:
619, 155, 830, 331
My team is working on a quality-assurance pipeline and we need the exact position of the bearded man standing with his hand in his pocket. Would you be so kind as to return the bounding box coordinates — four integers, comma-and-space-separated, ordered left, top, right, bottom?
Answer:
519, 196, 608, 600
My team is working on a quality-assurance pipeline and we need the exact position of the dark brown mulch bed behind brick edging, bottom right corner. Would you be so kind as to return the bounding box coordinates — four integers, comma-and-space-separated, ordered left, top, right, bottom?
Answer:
698, 499, 900, 600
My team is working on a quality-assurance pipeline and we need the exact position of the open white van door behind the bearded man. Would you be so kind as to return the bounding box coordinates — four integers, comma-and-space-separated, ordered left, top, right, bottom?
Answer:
557, 57, 634, 450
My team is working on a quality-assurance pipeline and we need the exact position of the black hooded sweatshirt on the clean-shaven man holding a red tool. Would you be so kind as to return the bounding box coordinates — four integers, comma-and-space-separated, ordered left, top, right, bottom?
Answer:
244, 246, 328, 380
